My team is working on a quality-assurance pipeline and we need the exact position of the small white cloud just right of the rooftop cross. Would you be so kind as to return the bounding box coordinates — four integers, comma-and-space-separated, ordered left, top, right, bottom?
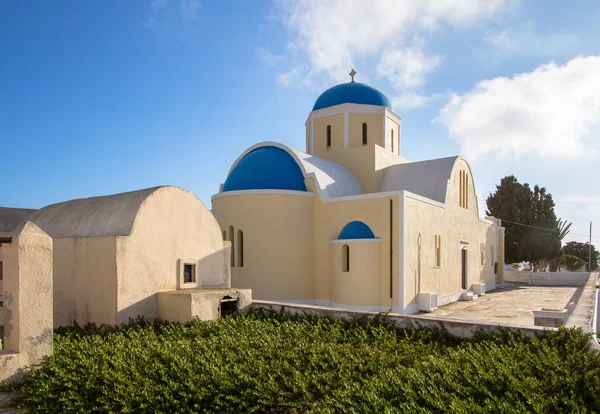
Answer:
377, 48, 441, 88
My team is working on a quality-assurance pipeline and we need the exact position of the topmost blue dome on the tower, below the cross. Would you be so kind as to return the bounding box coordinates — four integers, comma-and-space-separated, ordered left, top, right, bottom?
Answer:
313, 82, 392, 111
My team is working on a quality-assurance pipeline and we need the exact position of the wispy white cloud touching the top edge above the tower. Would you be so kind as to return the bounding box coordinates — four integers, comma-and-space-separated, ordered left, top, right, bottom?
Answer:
272, 0, 515, 84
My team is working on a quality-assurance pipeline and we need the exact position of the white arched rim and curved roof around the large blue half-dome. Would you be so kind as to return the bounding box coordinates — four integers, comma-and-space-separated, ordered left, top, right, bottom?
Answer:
222, 142, 363, 198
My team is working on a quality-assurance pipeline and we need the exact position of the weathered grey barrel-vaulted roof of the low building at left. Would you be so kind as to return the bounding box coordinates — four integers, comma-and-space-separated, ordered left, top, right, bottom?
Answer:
28, 187, 163, 238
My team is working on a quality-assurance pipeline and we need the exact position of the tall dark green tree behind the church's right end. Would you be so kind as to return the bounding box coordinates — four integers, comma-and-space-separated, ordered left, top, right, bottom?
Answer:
486, 175, 570, 270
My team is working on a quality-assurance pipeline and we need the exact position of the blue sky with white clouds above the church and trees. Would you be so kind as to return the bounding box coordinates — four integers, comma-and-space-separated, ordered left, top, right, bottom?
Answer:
0, 0, 600, 245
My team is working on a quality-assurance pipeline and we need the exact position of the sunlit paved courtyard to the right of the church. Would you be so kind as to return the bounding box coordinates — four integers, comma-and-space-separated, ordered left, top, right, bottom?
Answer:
419, 284, 583, 326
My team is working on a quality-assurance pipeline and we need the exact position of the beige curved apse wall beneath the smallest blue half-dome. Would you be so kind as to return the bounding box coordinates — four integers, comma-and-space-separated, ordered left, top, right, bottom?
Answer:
331, 240, 382, 306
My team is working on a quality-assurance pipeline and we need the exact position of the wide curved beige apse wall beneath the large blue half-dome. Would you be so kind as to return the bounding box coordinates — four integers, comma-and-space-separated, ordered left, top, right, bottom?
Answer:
212, 190, 315, 301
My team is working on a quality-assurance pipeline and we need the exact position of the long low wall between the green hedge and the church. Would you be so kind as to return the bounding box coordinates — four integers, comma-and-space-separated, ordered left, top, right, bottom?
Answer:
250, 300, 556, 338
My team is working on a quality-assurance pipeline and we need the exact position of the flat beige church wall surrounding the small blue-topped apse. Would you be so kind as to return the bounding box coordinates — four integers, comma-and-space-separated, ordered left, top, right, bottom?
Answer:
315, 196, 399, 307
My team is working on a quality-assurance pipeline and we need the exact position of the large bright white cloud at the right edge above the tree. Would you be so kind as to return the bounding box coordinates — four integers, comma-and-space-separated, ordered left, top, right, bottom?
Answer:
437, 56, 600, 159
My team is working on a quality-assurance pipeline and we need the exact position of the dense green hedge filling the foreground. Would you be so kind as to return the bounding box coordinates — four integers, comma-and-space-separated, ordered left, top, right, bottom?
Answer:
4, 311, 600, 413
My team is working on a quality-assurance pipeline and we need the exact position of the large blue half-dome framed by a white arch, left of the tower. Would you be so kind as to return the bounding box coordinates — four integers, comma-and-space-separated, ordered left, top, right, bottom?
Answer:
223, 146, 307, 191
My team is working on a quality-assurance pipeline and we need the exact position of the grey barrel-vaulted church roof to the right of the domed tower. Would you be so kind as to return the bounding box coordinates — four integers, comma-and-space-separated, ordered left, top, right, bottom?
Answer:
381, 157, 459, 203
